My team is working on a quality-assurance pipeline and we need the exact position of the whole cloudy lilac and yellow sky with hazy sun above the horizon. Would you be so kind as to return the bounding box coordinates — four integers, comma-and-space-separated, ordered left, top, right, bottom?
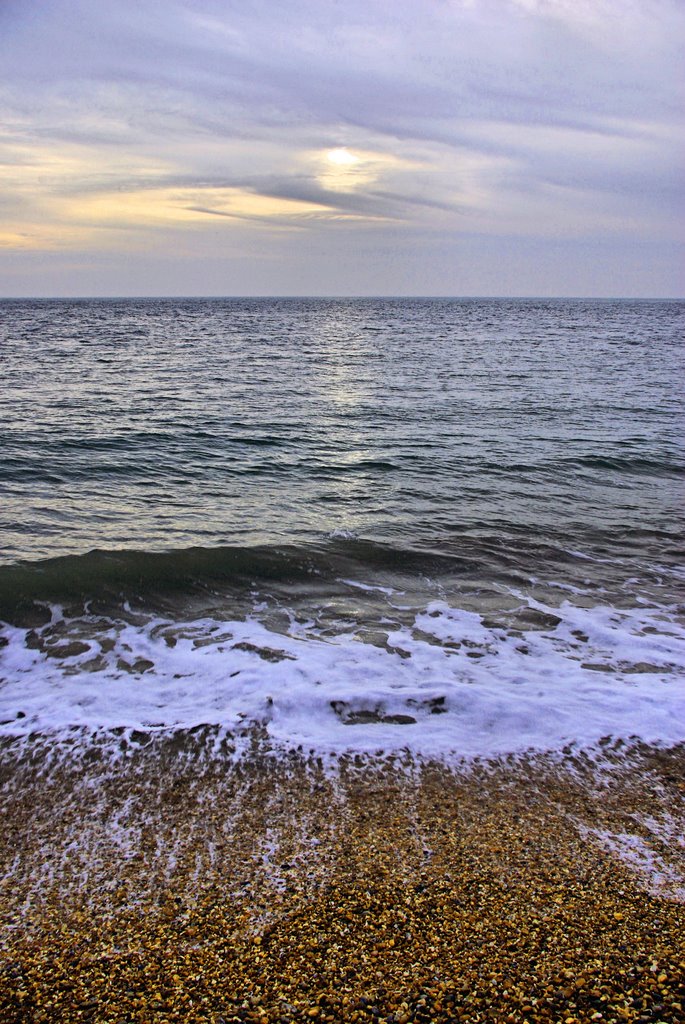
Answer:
0, 0, 685, 297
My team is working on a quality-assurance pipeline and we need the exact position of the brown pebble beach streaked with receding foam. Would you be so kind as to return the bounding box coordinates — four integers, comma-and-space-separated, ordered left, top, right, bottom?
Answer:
0, 730, 685, 1024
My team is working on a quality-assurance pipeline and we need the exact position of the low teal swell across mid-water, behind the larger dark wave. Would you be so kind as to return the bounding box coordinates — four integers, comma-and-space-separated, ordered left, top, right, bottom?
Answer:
0, 450, 685, 497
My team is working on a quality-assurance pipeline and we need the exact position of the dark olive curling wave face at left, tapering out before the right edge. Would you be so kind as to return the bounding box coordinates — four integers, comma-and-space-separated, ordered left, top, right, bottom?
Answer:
0, 530, 544, 622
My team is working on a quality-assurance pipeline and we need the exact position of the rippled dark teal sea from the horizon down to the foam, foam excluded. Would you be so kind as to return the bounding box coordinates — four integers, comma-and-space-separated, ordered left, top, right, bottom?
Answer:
0, 299, 685, 604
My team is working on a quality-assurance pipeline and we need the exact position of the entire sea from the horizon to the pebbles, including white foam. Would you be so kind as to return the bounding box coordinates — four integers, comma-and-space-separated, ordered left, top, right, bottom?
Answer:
0, 299, 685, 759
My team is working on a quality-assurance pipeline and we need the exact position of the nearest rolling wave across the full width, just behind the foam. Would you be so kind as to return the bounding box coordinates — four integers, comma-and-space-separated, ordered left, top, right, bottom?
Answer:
0, 523, 683, 624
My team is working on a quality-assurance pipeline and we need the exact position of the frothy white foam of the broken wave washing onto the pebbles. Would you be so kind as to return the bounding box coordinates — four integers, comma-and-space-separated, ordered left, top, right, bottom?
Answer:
0, 601, 685, 758
